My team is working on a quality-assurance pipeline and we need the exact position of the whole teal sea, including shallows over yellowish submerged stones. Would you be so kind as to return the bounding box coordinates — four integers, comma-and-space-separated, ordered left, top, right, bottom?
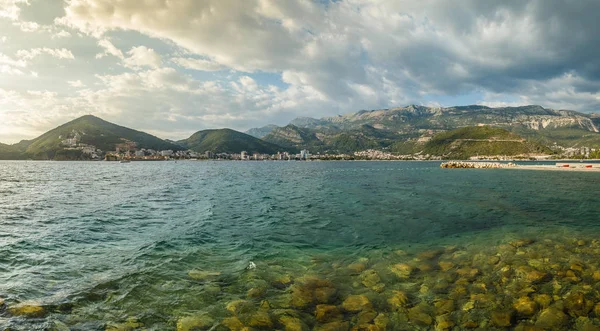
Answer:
0, 161, 600, 331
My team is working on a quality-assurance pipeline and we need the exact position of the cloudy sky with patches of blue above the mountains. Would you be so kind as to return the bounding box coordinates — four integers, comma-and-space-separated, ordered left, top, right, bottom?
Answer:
0, 0, 600, 143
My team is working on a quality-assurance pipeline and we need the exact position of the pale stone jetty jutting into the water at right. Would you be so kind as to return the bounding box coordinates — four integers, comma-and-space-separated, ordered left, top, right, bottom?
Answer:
440, 161, 600, 172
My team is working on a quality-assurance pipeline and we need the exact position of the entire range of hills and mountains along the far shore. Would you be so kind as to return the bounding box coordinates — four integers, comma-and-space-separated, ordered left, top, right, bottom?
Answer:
0, 105, 600, 160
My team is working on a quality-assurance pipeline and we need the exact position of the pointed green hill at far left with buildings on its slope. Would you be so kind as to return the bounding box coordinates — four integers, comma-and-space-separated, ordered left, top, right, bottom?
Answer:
0, 115, 182, 160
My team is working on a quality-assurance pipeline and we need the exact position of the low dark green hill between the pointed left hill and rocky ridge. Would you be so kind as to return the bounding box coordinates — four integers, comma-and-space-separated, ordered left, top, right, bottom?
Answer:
177, 129, 284, 154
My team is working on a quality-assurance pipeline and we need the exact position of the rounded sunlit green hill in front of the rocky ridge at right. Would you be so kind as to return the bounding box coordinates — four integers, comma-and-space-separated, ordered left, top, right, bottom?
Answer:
423, 126, 552, 159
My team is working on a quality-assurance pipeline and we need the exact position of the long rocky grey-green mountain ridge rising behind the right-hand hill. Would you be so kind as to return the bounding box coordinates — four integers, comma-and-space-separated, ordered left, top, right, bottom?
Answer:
256, 105, 600, 152
